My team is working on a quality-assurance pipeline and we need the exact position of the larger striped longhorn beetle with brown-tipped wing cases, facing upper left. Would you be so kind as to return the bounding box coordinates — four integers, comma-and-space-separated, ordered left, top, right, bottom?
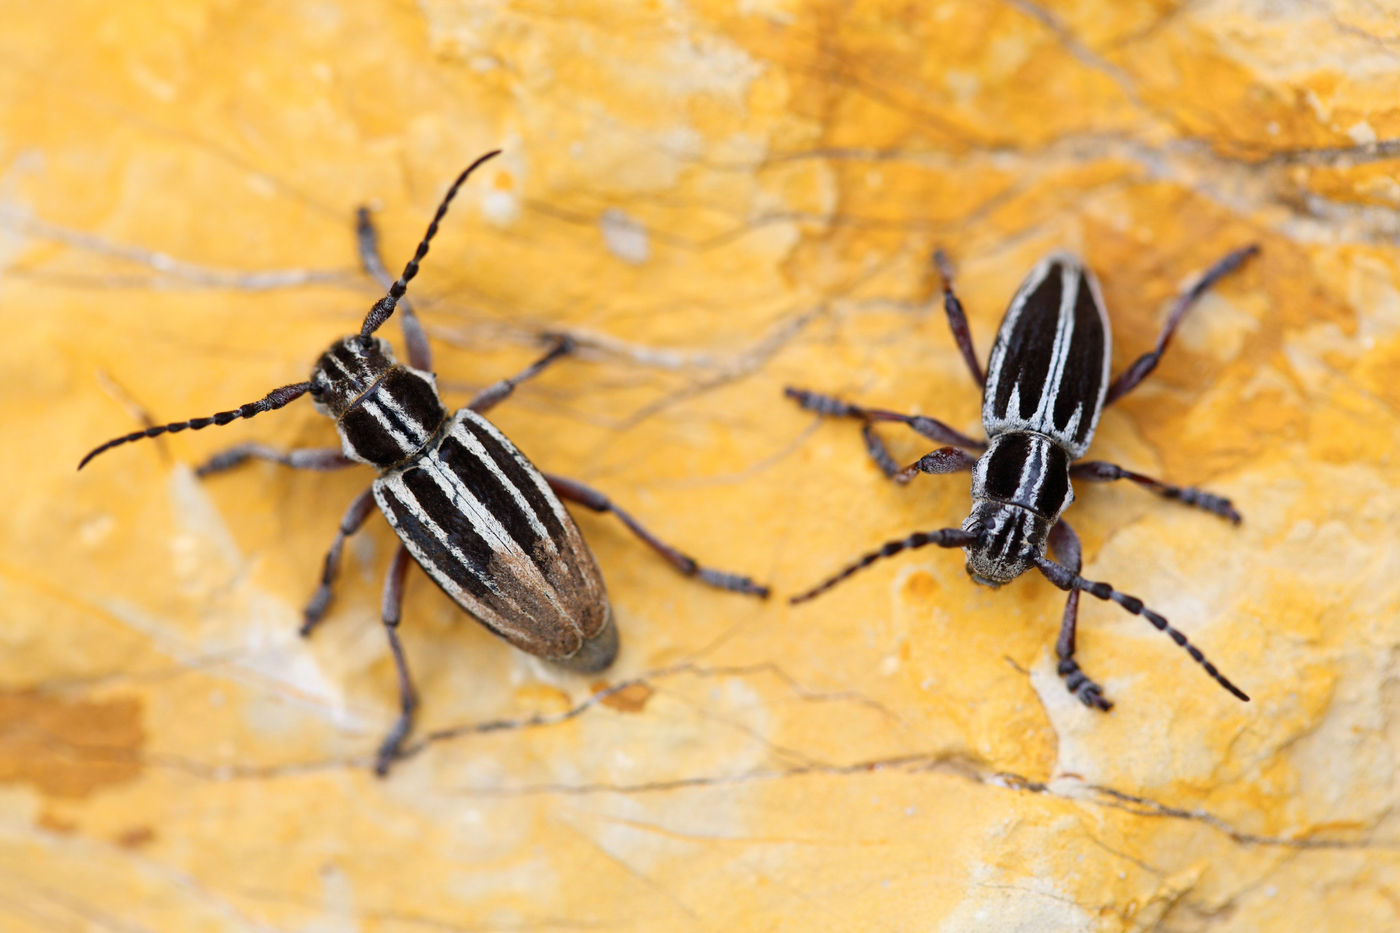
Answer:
78, 151, 769, 775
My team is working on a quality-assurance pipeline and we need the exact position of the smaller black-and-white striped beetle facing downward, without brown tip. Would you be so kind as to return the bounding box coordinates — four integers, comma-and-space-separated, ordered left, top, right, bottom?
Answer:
787, 245, 1259, 710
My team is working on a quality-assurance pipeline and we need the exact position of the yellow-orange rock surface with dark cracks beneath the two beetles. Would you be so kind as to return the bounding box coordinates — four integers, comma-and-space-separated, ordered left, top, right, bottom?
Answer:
0, 0, 1400, 932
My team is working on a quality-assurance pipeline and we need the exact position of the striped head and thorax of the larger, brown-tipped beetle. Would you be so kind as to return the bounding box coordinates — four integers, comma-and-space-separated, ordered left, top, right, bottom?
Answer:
311, 333, 448, 469
